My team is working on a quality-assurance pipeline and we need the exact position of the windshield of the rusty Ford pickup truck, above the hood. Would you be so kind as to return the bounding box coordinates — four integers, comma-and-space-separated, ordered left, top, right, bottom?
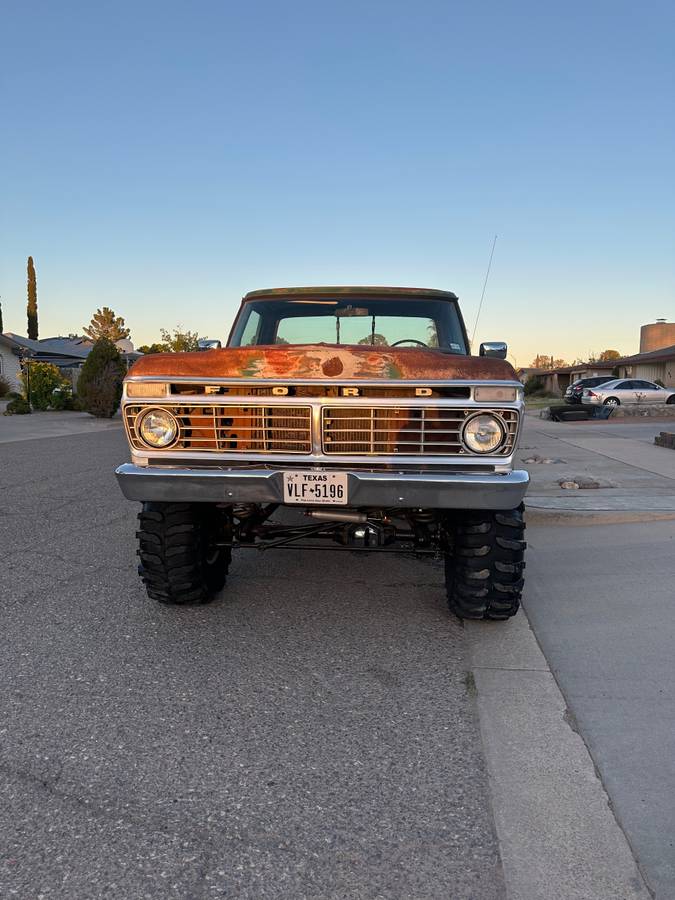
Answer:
230, 297, 467, 354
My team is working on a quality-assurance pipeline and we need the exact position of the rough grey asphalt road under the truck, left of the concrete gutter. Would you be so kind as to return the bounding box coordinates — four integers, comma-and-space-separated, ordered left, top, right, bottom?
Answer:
0, 431, 504, 900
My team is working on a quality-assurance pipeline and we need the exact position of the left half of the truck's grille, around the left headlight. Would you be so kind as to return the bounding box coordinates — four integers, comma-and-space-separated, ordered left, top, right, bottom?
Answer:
124, 403, 312, 453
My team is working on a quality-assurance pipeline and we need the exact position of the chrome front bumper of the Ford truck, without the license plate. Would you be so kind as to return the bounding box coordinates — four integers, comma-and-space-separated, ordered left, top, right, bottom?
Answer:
115, 463, 530, 509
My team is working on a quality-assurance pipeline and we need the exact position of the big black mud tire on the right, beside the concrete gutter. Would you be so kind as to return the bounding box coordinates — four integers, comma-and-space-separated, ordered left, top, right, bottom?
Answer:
445, 504, 525, 621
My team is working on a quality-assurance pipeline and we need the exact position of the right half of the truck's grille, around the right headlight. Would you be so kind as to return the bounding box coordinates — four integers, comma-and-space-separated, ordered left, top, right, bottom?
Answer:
321, 406, 518, 456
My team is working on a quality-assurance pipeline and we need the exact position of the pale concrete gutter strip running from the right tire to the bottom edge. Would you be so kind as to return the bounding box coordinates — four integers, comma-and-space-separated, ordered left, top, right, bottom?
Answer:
465, 612, 650, 900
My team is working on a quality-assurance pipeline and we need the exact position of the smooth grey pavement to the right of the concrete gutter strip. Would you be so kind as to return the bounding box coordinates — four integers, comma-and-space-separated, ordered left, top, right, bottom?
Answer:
525, 516, 675, 900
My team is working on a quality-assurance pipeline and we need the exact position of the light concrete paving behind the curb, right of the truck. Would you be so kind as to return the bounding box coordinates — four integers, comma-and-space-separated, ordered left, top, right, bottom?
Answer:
517, 415, 675, 513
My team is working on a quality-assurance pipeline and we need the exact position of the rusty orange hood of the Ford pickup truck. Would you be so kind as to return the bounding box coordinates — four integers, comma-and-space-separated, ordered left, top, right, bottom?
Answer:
129, 344, 517, 381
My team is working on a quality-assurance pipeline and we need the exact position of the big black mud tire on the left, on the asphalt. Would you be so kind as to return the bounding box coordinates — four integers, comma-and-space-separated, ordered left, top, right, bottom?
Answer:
136, 503, 231, 605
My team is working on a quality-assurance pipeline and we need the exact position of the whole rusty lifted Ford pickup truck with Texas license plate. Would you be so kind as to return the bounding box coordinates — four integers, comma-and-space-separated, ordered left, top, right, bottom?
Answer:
117, 287, 528, 619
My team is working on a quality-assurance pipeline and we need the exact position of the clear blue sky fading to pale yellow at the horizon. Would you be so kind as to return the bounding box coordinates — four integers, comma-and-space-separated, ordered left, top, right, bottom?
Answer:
0, 0, 675, 366
